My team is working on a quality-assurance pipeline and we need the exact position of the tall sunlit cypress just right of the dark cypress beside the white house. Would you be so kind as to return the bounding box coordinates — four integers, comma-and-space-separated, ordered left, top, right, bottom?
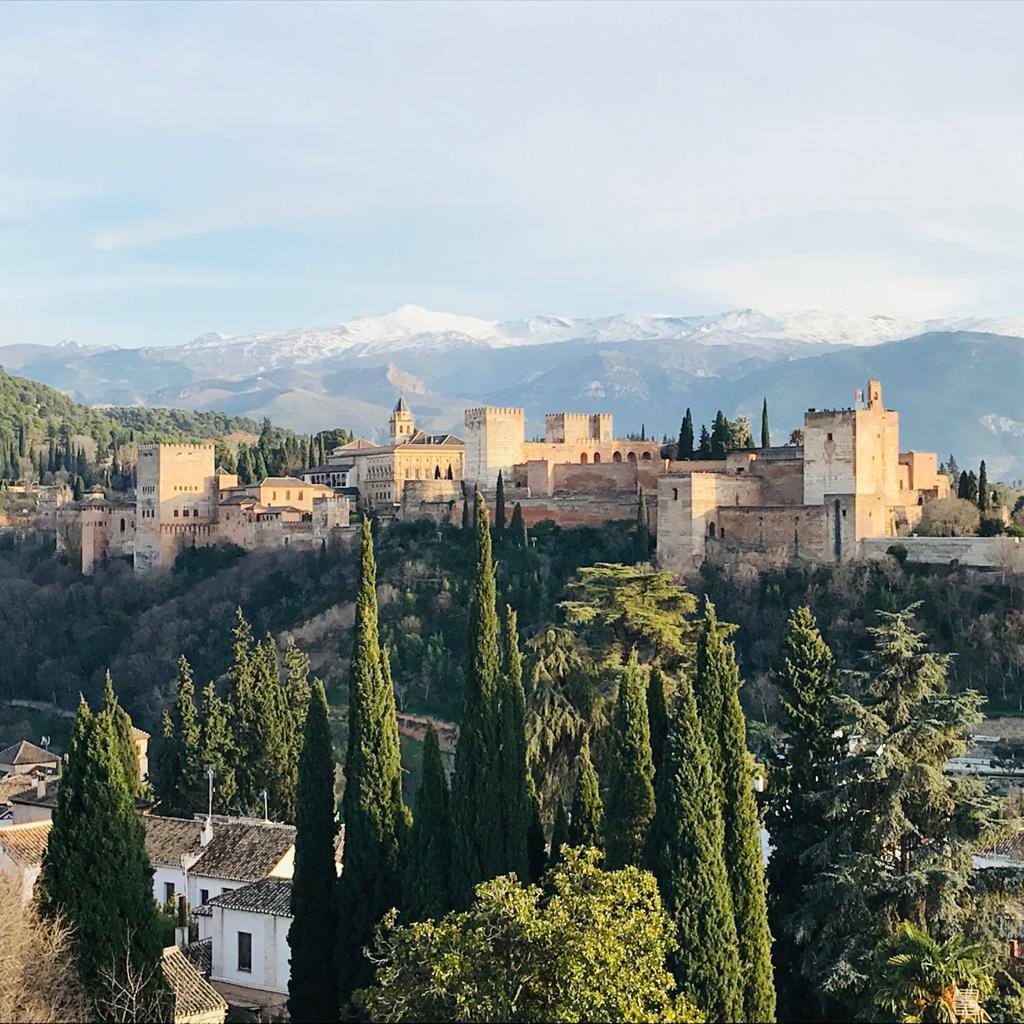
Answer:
338, 518, 408, 1002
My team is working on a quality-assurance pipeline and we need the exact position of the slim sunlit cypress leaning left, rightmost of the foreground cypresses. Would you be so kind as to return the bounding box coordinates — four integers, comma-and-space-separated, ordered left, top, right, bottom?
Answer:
697, 599, 775, 1021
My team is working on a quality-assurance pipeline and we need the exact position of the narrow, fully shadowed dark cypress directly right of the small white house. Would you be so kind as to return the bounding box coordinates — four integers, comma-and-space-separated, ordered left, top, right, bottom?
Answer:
288, 679, 338, 1024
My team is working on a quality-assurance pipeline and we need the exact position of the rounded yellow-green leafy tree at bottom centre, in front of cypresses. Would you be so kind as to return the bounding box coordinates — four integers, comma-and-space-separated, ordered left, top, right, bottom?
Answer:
358, 850, 702, 1022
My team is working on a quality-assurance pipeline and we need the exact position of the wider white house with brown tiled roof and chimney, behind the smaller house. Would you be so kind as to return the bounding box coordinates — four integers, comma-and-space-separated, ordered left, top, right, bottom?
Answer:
142, 814, 295, 907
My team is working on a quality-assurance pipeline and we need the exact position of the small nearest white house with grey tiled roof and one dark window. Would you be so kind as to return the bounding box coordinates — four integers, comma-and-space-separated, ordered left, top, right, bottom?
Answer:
197, 878, 292, 1010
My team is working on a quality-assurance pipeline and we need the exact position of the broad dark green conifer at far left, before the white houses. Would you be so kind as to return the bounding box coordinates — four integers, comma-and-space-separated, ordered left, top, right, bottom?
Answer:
38, 699, 162, 1019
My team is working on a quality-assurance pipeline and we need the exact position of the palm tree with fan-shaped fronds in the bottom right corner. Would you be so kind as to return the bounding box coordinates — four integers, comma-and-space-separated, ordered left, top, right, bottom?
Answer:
874, 921, 995, 1022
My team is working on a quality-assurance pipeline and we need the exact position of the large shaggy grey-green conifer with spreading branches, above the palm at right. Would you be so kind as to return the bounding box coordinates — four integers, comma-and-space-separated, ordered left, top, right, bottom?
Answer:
799, 609, 1009, 1017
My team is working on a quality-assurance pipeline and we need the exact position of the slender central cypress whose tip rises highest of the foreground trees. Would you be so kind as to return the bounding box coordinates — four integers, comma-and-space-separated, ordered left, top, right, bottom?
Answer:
452, 493, 506, 905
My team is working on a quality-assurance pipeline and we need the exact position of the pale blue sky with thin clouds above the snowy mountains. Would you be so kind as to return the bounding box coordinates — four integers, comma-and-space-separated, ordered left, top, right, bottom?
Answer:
0, 2, 1024, 345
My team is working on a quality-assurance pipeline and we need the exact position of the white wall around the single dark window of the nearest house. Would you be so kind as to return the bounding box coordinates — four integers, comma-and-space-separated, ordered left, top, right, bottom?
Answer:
209, 907, 292, 994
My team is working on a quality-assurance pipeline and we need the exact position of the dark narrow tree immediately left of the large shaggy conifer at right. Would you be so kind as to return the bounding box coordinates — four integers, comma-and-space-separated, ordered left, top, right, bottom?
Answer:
766, 605, 841, 1020
